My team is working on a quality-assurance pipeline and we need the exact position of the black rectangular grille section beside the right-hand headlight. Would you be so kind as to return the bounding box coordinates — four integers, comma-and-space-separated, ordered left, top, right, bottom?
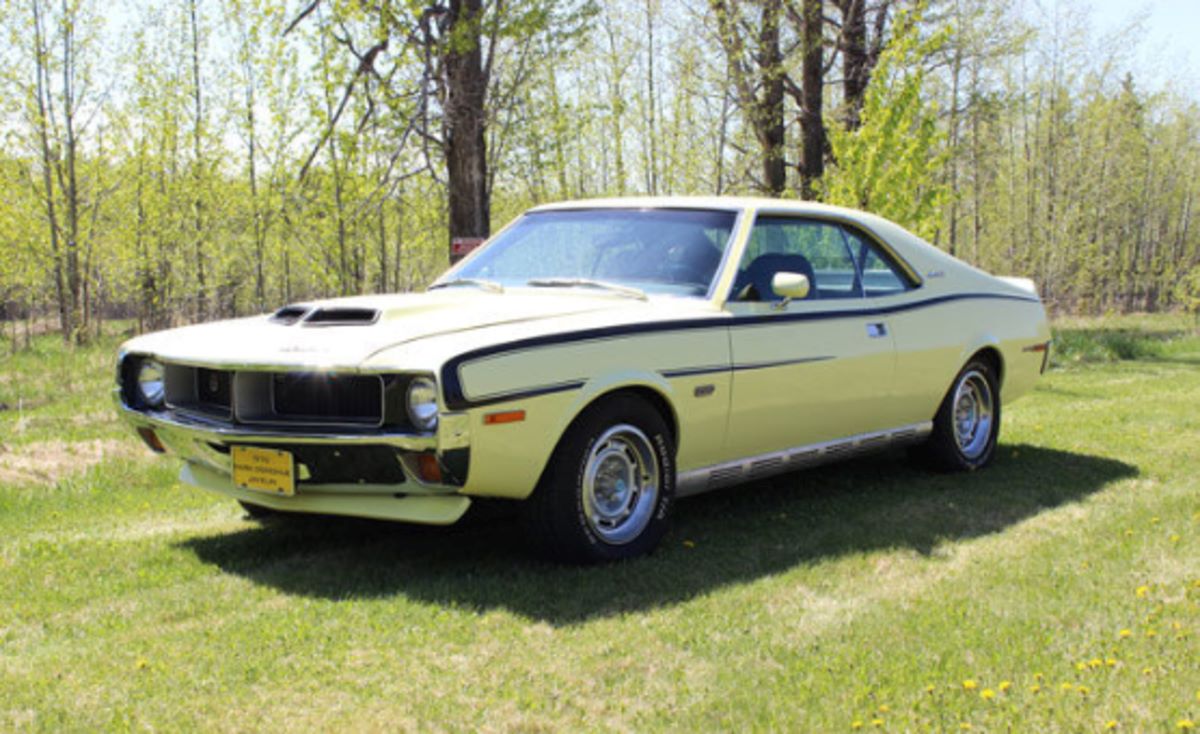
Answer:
271, 373, 383, 425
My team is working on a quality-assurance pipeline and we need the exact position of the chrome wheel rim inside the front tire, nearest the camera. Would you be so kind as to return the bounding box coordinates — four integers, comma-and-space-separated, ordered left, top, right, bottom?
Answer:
582, 423, 660, 546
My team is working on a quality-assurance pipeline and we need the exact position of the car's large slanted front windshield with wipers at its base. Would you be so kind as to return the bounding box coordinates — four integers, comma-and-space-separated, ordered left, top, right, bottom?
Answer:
451, 209, 737, 296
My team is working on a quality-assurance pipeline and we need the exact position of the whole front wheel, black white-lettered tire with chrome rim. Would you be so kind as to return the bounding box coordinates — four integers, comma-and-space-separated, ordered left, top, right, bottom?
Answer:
524, 395, 676, 564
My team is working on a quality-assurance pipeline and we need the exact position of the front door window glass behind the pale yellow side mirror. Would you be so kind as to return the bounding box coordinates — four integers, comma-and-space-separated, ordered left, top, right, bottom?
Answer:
733, 217, 863, 301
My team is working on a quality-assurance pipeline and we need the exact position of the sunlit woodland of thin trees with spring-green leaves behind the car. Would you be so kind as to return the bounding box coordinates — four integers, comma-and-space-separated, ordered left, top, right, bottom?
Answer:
0, 0, 1200, 350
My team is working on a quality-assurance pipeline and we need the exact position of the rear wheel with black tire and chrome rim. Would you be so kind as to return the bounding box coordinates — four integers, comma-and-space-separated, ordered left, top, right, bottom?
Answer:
923, 357, 1000, 471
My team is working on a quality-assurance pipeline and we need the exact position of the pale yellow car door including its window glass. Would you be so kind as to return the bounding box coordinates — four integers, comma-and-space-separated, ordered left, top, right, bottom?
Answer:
725, 216, 895, 457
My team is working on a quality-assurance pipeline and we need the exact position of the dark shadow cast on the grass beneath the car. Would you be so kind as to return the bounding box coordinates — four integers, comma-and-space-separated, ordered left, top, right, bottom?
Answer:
180, 445, 1138, 625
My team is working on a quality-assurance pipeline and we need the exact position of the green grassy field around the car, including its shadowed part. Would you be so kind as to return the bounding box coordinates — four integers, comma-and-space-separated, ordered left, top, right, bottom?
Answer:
0, 317, 1200, 732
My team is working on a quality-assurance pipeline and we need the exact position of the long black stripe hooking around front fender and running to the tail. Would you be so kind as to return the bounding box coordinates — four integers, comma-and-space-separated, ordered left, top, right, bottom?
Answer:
440, 293, 1042, 410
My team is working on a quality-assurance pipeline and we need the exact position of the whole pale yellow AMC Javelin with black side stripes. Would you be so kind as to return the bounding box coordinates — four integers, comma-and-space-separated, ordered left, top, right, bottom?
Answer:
115, 198, 1050, 562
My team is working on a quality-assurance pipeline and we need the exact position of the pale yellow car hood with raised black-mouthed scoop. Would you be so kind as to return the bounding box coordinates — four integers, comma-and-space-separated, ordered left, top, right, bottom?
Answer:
122, 288, 705, 369
